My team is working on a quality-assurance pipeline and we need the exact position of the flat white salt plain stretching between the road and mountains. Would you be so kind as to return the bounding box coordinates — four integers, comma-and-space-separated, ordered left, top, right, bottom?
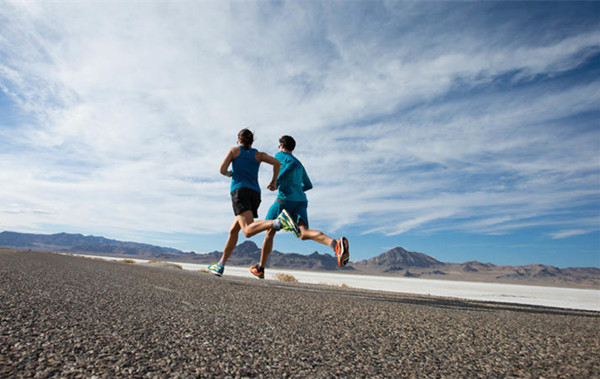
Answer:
72, 255, 600, 311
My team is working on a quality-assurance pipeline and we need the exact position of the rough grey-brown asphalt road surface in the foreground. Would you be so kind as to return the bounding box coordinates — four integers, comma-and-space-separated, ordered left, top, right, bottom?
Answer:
0, 249, 600, 378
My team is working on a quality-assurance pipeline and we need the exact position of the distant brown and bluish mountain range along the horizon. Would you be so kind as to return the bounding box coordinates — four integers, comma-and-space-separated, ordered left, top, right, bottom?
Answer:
0, 232, 600, 288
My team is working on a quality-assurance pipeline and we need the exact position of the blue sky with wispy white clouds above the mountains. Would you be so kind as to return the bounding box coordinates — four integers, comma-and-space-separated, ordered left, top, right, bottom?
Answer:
0, 0, 600, 267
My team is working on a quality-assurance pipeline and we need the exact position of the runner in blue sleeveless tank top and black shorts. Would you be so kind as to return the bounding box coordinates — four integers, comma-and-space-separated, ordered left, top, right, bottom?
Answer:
208, 129, 298, 276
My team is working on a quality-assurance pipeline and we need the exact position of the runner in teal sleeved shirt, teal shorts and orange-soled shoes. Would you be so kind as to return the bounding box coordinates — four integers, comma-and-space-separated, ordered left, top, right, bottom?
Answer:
250, 136, 350, 278
